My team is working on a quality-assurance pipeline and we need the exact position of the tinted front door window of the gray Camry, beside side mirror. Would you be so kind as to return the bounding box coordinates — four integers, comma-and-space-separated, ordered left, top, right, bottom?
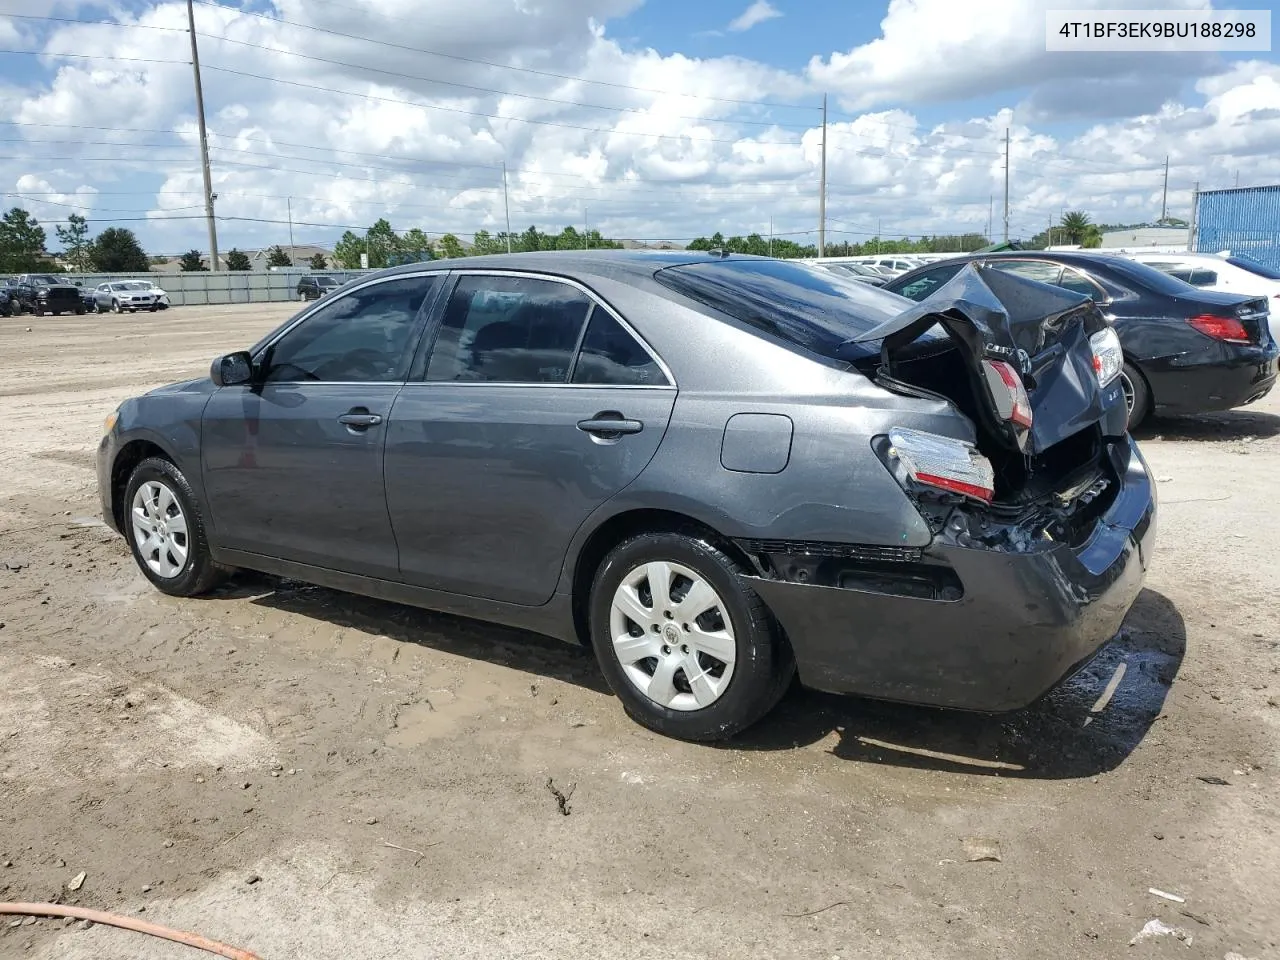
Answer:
262, 276, 439, 383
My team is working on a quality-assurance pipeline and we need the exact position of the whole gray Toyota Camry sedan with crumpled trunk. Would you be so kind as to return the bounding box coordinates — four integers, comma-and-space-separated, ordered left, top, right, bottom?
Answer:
99, 251, 1156, 740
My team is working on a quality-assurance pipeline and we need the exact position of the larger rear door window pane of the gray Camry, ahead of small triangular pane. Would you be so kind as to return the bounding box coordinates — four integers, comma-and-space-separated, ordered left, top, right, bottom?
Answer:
426, 275, 591, 383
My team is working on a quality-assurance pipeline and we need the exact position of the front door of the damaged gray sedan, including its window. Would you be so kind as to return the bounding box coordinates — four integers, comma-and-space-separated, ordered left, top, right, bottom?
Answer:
201, 275, 438, 579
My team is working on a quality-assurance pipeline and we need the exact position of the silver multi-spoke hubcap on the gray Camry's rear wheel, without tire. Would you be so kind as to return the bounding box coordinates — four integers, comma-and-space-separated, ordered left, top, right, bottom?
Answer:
609, 561, 737, 710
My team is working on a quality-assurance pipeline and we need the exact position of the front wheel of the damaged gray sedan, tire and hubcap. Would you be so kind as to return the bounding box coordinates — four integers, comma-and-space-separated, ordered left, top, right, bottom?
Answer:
124, 457, 227, 596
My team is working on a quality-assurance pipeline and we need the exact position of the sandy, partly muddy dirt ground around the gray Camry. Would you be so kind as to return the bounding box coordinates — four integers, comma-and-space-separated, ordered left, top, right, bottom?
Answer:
0, 305, 1280, 960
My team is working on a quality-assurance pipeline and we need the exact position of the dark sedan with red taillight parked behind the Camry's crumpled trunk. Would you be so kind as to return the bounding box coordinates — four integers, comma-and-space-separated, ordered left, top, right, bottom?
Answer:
884, 251, 1277, 426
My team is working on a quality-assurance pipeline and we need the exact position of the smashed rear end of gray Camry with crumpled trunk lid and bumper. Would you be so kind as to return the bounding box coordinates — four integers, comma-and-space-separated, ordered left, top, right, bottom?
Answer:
751, 266, 1156, 712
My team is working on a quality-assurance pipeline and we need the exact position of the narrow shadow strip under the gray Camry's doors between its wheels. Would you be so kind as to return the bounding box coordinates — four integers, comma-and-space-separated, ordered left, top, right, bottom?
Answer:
210, 571, 609, 694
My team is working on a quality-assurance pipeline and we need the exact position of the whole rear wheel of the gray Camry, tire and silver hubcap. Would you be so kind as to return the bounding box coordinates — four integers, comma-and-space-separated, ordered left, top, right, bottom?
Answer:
590, 532, 795, 741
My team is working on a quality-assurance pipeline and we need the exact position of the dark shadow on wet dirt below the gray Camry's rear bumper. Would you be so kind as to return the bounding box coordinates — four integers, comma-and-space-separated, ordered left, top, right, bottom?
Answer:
724, 590, 1187, 780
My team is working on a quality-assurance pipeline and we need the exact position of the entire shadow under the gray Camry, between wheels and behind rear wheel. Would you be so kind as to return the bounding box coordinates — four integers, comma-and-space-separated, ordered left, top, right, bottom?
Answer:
217, 572, 1187, 780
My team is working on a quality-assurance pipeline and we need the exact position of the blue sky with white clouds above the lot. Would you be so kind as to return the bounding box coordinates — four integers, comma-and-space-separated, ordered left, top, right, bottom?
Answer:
0, 0, 1280, 252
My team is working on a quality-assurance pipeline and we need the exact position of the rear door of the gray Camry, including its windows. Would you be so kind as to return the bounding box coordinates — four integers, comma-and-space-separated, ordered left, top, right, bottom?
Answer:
385, 271, 676, 604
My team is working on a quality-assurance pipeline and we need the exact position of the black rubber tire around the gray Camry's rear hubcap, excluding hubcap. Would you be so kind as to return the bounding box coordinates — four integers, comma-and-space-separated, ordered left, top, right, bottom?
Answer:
589, 532, 795, 742
